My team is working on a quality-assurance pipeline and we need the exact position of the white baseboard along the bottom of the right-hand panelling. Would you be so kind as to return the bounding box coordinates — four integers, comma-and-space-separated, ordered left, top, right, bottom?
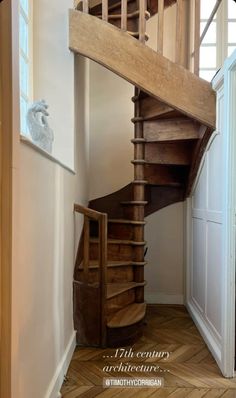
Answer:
186, 302, 221, 368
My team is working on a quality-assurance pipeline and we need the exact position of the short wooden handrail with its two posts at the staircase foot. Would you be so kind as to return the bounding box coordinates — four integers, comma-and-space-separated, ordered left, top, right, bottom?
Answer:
74, 204, 107, 346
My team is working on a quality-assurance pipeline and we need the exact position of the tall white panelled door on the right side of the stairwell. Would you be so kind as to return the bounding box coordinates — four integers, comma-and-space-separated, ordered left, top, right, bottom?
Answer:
186, 52, 236, 377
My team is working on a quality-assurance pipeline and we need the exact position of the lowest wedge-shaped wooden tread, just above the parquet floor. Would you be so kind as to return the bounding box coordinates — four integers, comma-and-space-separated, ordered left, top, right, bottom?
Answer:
107, 303, 146, 328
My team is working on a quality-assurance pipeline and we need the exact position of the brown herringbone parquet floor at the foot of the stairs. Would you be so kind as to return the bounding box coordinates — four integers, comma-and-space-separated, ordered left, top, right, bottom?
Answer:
61, 305, 236, 398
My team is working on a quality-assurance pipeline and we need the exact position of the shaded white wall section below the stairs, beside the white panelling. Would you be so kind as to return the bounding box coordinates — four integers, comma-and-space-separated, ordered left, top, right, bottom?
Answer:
145, 203, 184, 304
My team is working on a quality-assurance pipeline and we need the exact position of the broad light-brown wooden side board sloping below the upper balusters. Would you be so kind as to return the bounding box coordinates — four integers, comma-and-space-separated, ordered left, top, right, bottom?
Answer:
69, 10, 216, 128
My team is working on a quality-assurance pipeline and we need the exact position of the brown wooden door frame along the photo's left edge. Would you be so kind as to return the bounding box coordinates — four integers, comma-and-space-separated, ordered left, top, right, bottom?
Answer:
0, 0, 14, 398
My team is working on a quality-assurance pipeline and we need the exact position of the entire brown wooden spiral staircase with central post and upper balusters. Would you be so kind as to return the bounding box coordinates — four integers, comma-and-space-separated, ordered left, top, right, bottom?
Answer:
70, 0, 216, 346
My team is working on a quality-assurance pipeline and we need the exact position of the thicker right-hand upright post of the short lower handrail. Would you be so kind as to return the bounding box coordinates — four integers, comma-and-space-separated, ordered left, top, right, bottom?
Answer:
99, 214, 107, 347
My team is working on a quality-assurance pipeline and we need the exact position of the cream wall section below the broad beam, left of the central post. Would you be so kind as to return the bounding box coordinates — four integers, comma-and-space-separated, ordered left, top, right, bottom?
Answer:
89, 61, 134, 200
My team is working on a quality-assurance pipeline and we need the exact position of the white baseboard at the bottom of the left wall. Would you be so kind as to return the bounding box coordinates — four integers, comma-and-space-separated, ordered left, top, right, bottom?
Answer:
45, 331, 76, 398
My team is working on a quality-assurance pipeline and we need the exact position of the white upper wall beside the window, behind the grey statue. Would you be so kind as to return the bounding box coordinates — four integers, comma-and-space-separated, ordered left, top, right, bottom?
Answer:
32, 0, 74, 169
